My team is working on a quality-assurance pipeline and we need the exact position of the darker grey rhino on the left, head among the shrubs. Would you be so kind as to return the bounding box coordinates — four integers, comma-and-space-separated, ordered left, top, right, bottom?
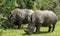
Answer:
2, 8, 33, 29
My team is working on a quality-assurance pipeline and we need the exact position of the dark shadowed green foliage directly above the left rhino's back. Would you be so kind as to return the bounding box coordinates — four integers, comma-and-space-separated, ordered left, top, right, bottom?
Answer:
17, 0, 34, 9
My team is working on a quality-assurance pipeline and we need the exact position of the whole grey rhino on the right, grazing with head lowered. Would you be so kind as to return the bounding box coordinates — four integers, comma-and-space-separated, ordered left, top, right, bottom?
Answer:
24, 10, 58, 34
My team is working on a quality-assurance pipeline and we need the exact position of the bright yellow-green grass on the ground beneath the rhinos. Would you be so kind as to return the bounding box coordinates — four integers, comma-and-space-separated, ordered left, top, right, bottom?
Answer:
0, 21, 60, 36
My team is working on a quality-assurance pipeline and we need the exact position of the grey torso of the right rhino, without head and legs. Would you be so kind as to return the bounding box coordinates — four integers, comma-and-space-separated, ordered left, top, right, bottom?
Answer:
32, 10, 57, 26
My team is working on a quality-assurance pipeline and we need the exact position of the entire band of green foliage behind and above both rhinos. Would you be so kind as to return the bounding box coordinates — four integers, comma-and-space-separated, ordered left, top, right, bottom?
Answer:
0, 0, 60, 24
